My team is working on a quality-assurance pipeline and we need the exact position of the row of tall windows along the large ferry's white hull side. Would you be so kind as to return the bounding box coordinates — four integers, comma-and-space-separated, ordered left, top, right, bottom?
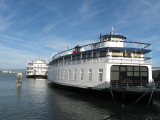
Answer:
54, 69, 103, 81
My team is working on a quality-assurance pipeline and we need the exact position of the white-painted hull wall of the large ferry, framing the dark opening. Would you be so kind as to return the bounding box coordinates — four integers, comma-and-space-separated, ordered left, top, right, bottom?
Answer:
48, 59, 152, 90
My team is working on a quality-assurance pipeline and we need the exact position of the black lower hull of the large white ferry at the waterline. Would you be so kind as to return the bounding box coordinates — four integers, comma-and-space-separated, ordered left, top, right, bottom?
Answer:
49, 82, 154, 104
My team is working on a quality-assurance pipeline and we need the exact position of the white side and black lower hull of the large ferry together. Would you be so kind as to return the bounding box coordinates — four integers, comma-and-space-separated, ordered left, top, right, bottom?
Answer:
48, 60, 152, 103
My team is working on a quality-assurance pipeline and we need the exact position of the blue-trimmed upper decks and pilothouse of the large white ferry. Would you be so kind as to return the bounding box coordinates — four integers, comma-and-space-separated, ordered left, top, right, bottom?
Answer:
50, 30, 151, 64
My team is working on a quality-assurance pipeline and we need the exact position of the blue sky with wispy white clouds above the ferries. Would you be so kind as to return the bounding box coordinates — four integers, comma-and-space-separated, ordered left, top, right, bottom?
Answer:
0, 0, 160, 69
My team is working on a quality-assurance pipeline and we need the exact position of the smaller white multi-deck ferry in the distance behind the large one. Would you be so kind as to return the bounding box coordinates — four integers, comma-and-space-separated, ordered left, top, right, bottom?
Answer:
26, 59, 48, 78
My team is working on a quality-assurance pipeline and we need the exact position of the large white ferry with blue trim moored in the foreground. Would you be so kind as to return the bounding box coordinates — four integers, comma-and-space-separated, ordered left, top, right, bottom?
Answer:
48, 30, 154, 101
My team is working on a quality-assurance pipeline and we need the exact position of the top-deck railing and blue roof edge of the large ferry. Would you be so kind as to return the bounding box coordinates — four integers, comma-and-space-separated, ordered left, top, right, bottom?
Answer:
52, 41, 151, 60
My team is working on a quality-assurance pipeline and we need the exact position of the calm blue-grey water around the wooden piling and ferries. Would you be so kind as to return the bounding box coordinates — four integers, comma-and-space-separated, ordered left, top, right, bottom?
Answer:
0, 73, 160, 120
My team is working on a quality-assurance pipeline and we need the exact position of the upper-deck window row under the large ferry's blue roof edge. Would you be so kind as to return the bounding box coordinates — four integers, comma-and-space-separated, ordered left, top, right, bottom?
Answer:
51, 50, 144, 64
